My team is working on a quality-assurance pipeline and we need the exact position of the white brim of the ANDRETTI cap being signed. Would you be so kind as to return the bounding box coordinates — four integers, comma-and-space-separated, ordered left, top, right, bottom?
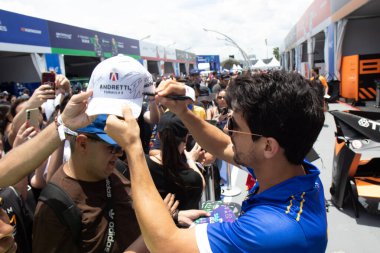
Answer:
86, 97, 143, 118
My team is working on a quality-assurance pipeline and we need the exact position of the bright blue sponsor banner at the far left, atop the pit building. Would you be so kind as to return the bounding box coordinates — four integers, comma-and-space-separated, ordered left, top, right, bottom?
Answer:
0, 10, 50, 47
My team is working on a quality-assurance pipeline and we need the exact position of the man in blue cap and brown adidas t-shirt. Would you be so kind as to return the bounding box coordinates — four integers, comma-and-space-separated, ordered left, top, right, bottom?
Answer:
33, 115, 140, 252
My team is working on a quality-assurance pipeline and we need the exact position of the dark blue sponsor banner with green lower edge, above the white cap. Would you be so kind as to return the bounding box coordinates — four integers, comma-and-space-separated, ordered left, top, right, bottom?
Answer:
48, 21, 140, 58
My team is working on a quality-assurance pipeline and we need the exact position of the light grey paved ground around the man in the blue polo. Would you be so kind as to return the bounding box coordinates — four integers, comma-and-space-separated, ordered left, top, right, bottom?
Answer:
225, 103, 380, 253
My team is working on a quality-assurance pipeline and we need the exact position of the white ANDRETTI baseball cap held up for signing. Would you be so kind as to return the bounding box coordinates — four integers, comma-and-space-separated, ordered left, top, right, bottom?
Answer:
86, 55, 155, 118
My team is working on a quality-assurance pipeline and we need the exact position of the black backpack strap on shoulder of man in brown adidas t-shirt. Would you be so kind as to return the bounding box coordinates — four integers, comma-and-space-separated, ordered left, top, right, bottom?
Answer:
38, 183, 82, 245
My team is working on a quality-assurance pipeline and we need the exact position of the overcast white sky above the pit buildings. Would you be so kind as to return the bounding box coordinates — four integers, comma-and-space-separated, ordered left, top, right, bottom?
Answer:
0, 0, 313, 60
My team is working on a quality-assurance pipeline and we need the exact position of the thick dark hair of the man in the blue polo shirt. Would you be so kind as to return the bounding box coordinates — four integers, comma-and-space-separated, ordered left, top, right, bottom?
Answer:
227, 71, 325, 164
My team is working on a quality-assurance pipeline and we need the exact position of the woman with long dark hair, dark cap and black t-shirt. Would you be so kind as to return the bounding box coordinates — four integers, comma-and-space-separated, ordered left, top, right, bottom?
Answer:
147, 112, 205, 210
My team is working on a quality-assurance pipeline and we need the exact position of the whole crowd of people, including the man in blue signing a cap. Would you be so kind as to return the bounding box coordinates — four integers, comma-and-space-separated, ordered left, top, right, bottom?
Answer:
0, 57, 327, 253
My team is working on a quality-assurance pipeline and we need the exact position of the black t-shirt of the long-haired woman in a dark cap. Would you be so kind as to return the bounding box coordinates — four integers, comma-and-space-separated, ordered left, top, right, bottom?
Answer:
146, 156, 202, 210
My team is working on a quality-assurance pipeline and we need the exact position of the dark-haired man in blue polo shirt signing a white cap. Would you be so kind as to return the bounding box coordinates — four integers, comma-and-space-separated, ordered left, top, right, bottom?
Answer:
106, 71, 327, 252
